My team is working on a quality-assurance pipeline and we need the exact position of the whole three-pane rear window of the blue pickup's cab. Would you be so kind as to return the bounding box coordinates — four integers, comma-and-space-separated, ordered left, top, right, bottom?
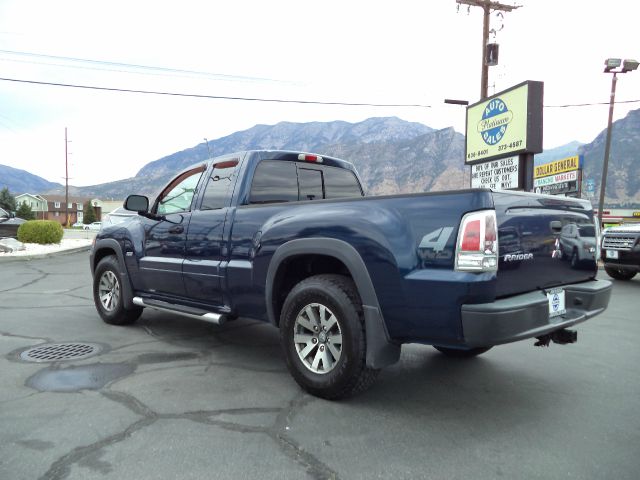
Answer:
249, 160, 362, 204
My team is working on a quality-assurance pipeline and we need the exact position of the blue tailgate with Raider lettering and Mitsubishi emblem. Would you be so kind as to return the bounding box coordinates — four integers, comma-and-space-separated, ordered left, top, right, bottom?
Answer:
493, 191, 597, 297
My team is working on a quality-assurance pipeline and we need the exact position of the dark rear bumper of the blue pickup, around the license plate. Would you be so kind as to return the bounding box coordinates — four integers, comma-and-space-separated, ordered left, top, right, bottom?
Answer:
462, 280, 611, 347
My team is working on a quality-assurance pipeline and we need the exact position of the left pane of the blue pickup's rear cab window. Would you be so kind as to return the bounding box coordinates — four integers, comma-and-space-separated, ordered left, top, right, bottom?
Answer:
249, 160, 298, 204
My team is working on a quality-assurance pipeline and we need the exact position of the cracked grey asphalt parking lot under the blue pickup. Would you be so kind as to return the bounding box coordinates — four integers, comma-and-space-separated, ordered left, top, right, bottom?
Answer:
0, 252, 640, 480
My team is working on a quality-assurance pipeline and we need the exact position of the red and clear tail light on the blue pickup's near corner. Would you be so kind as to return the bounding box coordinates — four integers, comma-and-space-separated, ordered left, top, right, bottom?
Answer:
456, 210, 498, 272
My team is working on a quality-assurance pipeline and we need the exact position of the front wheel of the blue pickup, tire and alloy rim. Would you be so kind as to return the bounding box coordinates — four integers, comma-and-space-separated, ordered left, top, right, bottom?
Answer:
93, 255, 142, 325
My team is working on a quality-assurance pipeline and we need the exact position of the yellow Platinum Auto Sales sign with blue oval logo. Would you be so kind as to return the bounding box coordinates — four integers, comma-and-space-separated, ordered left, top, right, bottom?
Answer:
465, 81, 543, 165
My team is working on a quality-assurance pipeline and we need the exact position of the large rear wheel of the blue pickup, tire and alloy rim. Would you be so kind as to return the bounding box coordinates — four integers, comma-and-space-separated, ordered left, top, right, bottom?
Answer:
280, 275, 380, 400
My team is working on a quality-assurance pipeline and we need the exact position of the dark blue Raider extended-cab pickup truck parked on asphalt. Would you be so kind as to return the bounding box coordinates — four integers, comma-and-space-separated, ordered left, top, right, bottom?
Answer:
90, 151, 611, 399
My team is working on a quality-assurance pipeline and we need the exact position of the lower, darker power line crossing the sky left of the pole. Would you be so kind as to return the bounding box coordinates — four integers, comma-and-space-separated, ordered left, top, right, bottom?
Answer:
0, 78, 431, 108
